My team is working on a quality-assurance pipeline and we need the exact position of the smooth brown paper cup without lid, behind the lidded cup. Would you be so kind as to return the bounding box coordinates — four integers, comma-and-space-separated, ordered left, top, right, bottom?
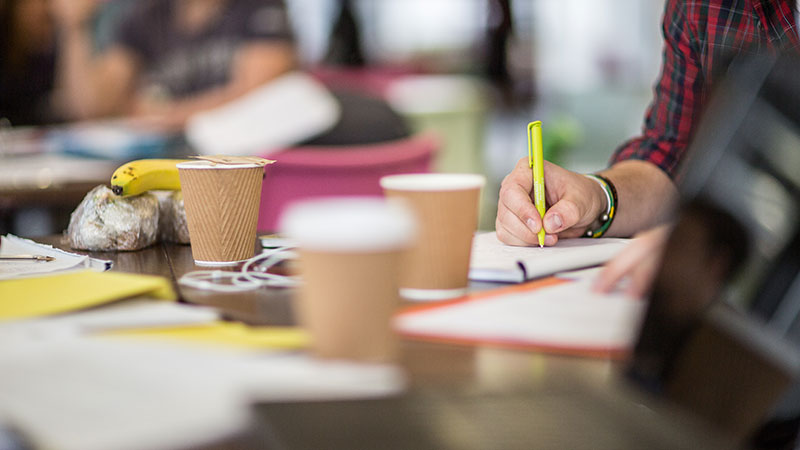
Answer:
381, 173, 485, 300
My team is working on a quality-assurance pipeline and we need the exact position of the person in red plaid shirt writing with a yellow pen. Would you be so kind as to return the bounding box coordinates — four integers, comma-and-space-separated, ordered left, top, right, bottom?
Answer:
496, 0, 800, 295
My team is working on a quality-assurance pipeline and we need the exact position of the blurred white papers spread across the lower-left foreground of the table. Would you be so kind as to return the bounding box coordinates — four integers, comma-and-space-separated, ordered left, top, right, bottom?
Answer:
0, 338, 405, 450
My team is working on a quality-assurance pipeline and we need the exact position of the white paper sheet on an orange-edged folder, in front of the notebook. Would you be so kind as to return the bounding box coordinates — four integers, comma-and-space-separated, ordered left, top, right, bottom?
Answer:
395, 281, 644, 353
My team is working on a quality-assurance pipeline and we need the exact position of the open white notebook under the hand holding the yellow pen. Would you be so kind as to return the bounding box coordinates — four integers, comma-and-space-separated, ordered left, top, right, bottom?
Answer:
469, 233, 631, 282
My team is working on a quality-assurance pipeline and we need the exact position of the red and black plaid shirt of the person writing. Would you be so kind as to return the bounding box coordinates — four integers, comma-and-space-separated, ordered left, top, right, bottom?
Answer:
611, 0, 800, 178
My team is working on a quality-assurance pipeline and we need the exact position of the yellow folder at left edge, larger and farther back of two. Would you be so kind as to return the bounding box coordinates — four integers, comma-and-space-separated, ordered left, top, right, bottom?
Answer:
0, 270, 176, 320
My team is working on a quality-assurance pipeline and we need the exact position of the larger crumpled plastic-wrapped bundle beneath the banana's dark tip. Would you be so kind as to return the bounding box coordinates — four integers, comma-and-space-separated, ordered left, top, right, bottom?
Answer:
67, 185, 159, 251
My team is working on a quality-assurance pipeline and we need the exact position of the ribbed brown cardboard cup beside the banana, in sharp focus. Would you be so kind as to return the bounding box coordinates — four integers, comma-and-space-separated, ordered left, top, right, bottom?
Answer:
178, 161, 264, 266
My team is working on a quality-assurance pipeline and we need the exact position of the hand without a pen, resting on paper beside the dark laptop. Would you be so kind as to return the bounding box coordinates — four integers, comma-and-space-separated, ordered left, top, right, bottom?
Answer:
593, 225, 670, 297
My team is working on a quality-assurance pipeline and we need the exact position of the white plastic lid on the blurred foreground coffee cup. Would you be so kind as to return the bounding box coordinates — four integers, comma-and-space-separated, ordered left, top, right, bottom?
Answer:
280, 197, 417, 252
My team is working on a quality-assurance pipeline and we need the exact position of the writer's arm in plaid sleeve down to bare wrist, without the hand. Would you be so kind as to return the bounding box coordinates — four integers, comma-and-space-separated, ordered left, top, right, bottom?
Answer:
602, 0, 692, 236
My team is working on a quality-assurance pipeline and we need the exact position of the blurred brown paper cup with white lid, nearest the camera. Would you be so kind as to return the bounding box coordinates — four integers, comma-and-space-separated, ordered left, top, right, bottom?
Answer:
281, 198, 415, 362
